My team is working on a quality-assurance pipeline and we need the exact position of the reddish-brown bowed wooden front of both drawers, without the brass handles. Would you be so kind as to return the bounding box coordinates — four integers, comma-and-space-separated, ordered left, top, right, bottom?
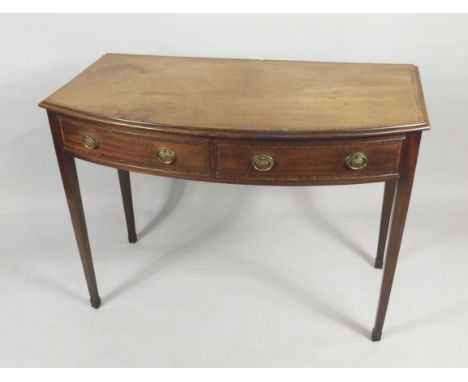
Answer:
58, 112, 404, 185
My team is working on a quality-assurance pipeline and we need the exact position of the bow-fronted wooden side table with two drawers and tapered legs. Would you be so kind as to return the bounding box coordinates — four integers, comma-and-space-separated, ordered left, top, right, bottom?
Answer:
40, 54, 429, 341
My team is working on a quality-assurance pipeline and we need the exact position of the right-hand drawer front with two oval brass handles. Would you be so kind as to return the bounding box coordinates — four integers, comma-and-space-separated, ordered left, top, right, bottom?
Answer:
216, 137, 404, 181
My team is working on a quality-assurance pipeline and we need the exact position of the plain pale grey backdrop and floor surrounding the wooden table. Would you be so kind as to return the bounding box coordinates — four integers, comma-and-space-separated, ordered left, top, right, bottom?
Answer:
0, 14, 468, 367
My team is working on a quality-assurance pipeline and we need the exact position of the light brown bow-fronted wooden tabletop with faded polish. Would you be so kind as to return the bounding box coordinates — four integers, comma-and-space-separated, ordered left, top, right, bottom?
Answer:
40, 54, 427, 133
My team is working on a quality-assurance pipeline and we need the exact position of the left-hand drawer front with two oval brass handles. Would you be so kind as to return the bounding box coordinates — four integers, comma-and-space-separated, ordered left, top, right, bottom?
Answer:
60, 119, 210, 176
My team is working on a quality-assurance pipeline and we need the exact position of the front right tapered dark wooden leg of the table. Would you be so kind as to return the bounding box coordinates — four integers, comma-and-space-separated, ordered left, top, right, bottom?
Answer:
372, 132, 421, 341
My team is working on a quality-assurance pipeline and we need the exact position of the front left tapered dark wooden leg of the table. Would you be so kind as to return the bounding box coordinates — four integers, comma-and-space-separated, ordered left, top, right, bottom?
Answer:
49, 114, 101, 309
